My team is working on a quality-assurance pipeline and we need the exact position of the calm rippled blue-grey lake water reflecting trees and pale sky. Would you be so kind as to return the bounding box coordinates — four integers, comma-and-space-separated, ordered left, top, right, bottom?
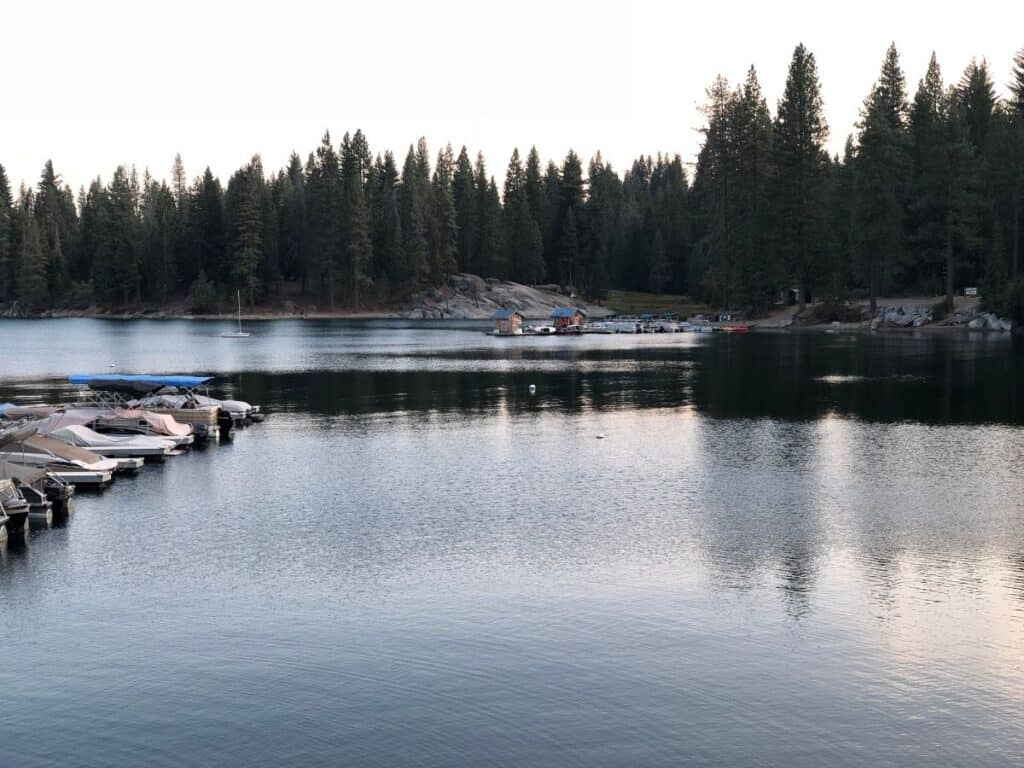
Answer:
0, 319, 1024, 768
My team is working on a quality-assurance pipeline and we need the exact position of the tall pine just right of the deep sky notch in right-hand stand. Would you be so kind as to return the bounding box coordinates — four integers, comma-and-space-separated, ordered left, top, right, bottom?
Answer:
854, 45, 910, 314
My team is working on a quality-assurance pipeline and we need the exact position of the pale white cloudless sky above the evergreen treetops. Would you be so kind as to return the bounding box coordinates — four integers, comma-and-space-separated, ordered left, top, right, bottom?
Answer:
0, 0, 1024, 189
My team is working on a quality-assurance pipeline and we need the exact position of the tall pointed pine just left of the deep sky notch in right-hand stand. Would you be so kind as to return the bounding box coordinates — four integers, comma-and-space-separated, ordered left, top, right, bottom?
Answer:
774, 44, 828, 310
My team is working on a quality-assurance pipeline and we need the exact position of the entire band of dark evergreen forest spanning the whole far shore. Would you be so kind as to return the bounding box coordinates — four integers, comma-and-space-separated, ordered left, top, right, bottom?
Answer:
0, 45, 1024, 311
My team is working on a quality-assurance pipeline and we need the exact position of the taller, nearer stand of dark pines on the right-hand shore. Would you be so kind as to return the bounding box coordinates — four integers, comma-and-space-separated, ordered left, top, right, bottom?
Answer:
689, 46, 1024, 319
